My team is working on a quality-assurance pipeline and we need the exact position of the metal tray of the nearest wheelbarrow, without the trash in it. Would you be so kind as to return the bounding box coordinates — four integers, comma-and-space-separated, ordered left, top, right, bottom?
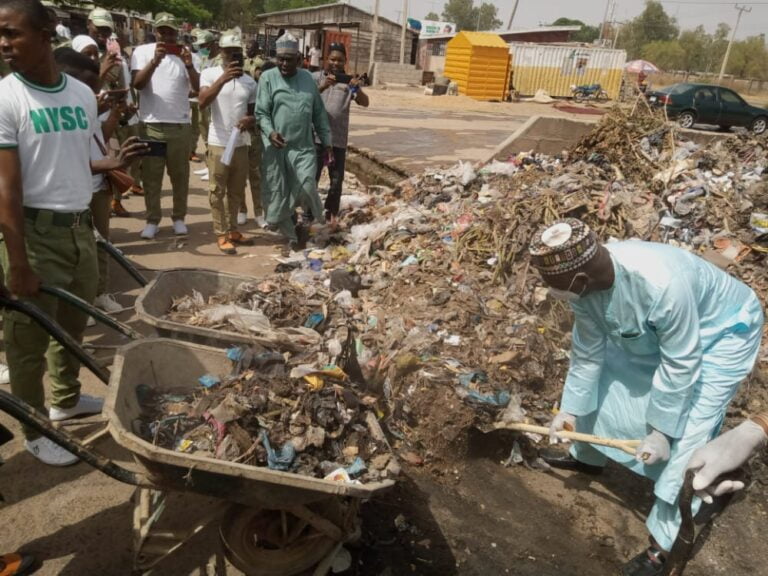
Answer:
104, 339, 394, 509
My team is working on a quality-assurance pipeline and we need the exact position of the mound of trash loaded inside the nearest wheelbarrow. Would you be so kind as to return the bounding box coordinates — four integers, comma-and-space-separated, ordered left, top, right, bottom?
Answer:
135, 348, 399, 483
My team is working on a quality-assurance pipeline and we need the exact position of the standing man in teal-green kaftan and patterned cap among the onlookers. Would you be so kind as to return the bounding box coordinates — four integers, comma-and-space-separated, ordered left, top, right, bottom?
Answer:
256, 33, 331, 246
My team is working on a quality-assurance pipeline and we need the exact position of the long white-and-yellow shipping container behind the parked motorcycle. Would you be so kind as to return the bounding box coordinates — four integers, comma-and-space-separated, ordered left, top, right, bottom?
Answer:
509, 42, 627, 99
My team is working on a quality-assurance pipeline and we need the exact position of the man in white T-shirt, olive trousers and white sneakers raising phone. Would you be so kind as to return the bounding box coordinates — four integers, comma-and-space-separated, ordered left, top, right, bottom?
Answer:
131, 12, 200, 240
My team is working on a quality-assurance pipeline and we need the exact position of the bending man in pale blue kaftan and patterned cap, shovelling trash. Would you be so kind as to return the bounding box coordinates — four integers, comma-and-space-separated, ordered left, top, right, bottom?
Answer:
530, 219, 763, 576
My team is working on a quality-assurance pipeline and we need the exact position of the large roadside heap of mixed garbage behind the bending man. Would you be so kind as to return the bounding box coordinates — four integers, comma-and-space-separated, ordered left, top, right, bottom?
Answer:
154, 108, 768, 463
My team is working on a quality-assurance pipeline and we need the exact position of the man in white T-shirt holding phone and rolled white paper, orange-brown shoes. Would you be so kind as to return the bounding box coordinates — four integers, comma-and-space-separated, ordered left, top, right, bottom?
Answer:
200, 29, 257, 254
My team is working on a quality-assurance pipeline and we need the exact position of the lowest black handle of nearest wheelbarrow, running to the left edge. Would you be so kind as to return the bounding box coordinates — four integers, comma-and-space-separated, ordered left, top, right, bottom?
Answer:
0, 390, 148, 486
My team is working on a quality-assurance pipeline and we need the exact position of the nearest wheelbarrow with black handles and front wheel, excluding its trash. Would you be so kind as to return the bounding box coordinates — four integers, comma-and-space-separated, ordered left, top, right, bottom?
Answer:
0, 297, 394, 576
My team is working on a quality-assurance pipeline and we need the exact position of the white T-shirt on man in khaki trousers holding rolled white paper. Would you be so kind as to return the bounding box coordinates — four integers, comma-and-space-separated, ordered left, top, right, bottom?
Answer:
200, 66, 258, 147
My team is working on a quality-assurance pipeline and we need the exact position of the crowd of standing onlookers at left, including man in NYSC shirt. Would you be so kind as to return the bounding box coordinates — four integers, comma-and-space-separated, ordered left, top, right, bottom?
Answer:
0, 0, 368, 465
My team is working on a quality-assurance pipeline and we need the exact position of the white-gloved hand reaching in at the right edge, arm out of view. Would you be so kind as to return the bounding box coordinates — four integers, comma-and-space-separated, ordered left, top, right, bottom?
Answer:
686, 420, 768, 504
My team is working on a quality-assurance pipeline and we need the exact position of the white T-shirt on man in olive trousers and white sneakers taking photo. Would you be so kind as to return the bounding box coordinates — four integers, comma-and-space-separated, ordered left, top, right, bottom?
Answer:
131, 44, 191, 124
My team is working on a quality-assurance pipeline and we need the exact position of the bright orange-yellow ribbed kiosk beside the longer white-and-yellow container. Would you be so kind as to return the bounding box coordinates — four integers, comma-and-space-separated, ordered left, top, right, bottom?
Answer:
444, 32, 509, 100
